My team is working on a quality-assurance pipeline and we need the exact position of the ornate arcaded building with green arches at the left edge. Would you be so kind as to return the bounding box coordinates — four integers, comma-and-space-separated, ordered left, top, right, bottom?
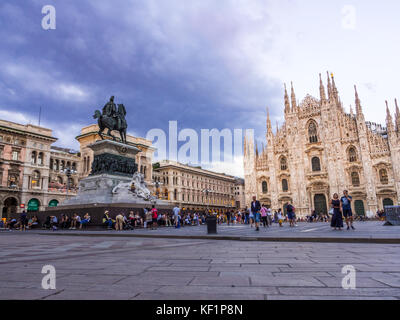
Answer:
0, 120, 80, 217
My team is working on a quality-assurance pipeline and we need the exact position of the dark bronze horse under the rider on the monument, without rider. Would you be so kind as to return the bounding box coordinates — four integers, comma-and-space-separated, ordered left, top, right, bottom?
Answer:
93, 104, 128, 143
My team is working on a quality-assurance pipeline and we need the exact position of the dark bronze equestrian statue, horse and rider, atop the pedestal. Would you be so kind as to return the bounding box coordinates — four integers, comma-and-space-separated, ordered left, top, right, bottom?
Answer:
93, 96, 128, 143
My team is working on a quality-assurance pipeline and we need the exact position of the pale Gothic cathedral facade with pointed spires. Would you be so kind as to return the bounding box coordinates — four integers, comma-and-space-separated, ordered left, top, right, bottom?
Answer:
244, 74, 400, 216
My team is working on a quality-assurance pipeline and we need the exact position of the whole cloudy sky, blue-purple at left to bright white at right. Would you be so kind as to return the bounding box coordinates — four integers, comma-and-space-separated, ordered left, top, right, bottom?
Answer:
0, 0, 400, 175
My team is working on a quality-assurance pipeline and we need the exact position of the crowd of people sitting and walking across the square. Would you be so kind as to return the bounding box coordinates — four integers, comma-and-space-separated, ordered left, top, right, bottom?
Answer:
0, 190, 394, 231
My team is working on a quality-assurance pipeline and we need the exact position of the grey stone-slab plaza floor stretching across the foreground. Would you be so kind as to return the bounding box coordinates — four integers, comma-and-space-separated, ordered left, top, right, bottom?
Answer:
0, 223, 400, 300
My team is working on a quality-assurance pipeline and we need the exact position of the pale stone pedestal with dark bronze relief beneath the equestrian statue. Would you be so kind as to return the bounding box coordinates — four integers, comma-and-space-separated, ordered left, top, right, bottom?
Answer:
52, 140, 172, 214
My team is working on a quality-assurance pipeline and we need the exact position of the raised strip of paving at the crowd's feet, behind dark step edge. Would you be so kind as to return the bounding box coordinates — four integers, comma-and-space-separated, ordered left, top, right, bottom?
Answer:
16, 221, 400, 244
